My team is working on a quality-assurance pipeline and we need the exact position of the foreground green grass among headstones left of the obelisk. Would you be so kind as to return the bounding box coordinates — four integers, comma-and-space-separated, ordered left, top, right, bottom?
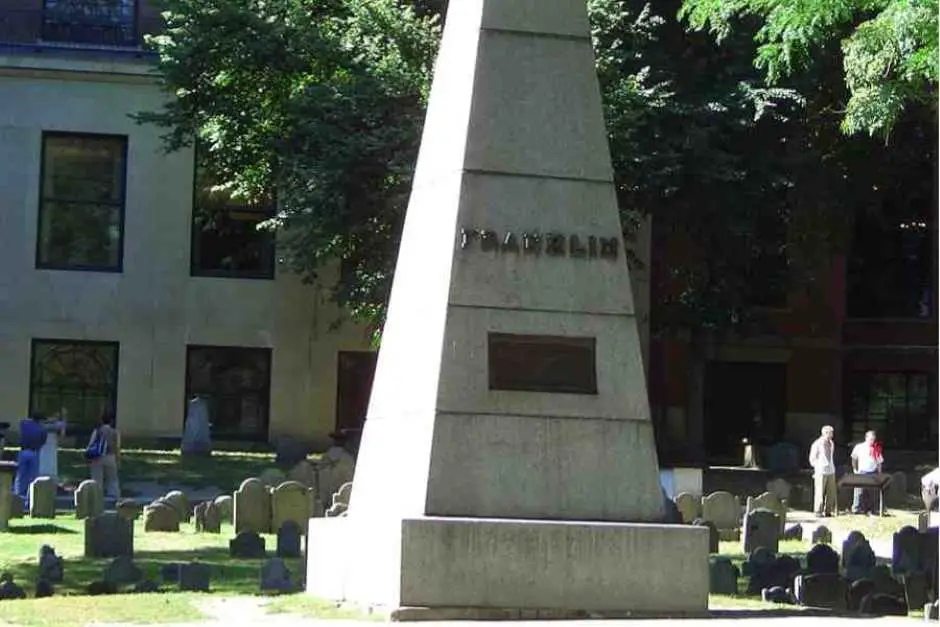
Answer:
0, 515, 302, 599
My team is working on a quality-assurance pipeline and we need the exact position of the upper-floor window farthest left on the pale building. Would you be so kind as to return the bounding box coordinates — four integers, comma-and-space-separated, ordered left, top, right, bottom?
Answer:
38, 135, 126, 270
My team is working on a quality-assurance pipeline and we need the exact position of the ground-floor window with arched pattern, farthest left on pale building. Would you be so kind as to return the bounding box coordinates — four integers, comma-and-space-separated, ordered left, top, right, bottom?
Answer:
29, 340, 120, 429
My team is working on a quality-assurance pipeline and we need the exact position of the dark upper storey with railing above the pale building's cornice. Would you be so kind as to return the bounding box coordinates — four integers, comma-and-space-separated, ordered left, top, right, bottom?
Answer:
0, 0, 163, 49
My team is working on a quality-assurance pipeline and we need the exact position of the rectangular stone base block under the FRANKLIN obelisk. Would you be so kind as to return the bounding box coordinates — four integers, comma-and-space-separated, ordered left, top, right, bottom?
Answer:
307, 516, 709, 620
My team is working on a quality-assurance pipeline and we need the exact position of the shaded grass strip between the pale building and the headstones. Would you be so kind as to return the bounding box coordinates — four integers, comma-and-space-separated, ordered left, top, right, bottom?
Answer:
59, 449, 275, 496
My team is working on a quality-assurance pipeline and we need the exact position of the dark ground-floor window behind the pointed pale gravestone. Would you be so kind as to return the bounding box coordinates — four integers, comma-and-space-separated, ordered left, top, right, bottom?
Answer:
186, 346, 271, 440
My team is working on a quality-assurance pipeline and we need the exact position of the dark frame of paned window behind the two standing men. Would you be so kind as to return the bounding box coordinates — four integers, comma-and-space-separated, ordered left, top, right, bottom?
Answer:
843, 369, 937, 450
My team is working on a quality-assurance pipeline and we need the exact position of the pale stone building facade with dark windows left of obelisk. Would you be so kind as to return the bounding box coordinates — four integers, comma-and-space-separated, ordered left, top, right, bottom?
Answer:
0, 0, 374, 443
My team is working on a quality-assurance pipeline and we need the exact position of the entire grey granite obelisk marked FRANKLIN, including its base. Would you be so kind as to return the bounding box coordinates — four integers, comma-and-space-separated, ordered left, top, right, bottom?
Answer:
307, 0, 708, 612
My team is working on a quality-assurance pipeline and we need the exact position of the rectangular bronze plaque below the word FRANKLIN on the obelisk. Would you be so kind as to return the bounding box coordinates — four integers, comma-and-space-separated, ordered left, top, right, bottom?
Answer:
488, 333, 597, 394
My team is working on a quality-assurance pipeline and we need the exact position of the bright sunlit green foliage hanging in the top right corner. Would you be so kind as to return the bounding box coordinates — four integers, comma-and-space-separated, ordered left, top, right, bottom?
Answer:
680, 0, 938, 137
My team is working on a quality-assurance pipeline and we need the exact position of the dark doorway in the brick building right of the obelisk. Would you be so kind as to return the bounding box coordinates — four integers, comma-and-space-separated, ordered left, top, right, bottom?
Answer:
704, 361, 787, 465
